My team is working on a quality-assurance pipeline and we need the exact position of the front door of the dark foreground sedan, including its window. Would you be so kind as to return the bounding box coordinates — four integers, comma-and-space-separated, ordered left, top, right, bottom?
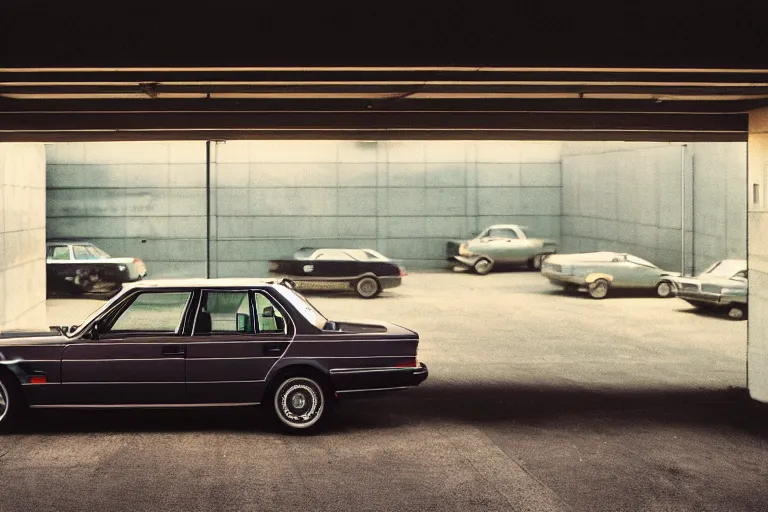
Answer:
61, 290, 192, 406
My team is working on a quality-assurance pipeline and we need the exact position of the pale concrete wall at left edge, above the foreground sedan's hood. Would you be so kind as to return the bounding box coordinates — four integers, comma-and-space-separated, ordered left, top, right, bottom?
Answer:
0, 144, 48, 330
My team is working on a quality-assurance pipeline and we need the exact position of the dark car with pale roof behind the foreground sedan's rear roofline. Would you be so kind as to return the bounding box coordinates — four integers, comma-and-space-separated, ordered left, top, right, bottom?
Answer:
269, 247, 407, 299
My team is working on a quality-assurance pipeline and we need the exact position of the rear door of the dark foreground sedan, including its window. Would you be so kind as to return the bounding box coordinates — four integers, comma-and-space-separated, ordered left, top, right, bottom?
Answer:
185, 289, 293, 405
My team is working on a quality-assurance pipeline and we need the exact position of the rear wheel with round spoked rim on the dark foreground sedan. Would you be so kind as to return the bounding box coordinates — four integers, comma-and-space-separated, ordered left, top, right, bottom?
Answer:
272, 374, 333, 434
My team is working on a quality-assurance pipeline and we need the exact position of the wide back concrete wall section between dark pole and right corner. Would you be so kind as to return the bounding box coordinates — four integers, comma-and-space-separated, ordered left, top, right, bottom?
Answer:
207, 141, 560, 276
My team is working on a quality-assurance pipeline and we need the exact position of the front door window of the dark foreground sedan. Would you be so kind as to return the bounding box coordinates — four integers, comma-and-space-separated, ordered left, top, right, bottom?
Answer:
106, 292, 190, 334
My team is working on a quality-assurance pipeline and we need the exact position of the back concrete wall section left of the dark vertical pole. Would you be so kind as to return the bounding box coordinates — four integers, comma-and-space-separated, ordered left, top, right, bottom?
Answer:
46, 142, 206, 277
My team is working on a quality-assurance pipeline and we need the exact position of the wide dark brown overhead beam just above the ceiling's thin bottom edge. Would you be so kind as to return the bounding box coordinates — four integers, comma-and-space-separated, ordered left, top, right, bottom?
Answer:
0, 111, 748, 133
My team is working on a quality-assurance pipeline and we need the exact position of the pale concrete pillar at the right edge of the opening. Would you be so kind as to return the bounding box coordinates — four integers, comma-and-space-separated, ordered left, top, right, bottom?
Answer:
747, 108, 768, 402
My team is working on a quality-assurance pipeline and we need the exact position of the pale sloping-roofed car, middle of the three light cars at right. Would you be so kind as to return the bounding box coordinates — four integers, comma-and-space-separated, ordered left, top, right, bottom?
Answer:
541, 251, 680, 299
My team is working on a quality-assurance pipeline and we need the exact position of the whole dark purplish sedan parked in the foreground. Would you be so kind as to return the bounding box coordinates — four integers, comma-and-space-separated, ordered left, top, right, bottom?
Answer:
0, 279, 427, 432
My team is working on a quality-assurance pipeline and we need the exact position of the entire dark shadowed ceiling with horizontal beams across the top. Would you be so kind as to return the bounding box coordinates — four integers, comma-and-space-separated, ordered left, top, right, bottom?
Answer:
0, 0, 768, 141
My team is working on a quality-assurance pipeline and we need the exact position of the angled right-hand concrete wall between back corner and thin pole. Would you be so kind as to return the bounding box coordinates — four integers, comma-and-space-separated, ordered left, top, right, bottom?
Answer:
562, 145, 692, 271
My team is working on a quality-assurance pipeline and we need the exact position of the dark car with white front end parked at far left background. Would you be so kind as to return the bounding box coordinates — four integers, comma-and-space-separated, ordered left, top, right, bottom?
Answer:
45, 240, 147, 296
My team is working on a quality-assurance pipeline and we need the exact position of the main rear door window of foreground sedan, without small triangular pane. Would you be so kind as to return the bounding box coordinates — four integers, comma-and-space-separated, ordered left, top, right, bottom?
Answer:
192, 290, 254, 336
